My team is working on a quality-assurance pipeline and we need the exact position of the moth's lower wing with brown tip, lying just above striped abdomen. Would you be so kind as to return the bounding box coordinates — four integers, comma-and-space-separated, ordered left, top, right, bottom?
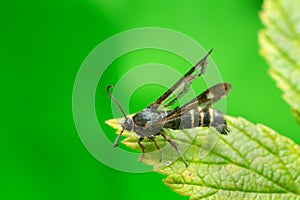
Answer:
162, 83, 231, 122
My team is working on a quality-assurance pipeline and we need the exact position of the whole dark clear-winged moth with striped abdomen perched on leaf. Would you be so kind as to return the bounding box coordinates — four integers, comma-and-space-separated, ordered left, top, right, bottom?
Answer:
106, 49, 231, 166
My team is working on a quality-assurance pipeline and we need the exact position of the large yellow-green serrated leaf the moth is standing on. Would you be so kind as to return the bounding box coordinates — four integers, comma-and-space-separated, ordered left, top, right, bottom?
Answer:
106, 117, 300, 199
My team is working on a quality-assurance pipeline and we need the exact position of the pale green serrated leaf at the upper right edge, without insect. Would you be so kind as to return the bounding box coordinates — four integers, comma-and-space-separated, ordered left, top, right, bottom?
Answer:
259, 0, 300, 123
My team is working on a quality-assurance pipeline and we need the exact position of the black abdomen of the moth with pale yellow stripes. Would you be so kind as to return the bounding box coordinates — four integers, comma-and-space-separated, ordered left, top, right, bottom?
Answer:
164, 107, 229, 134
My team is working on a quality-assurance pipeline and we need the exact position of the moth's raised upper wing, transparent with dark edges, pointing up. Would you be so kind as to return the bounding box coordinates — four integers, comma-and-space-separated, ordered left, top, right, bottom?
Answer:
148, 49, 213, 109
